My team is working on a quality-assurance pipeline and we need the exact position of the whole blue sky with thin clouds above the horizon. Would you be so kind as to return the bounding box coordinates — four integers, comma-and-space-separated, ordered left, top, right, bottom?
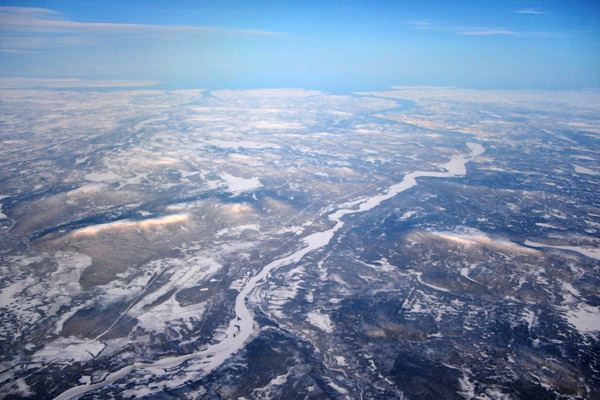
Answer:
0, 0, 600, 92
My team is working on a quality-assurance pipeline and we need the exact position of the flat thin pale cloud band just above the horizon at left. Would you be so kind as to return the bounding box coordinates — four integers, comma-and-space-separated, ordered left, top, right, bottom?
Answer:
0, 78, 162, 89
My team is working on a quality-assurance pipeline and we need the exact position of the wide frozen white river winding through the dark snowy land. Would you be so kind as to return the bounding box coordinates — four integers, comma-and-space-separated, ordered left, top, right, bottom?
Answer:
56, 143, 485, 400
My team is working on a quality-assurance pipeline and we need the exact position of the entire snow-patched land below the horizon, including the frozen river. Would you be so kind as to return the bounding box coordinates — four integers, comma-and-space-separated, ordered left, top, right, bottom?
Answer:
0, 87, 600, 399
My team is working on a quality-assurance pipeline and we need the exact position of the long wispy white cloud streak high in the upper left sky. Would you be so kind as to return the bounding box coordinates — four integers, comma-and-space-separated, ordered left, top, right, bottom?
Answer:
0, 6, 283, 51
